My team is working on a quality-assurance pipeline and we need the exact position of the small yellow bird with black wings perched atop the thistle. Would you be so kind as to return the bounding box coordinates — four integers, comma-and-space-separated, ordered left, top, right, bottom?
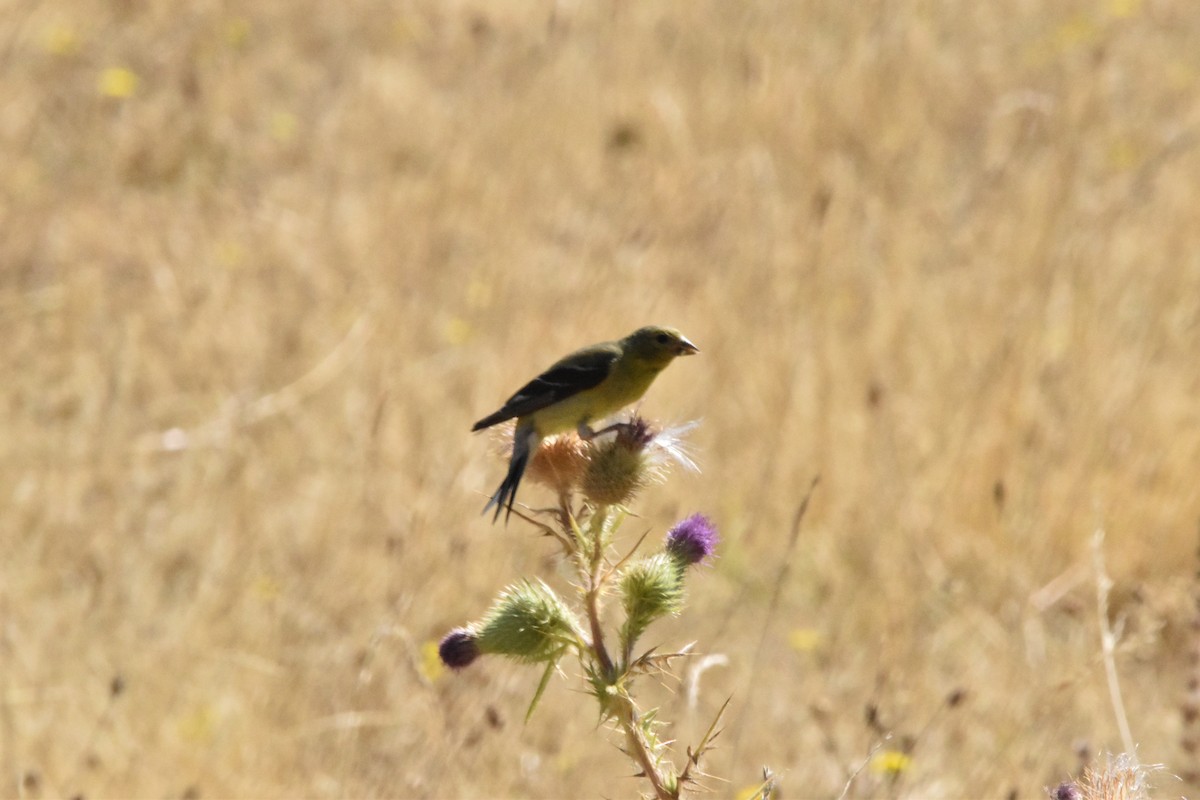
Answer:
470, 325, 700, 522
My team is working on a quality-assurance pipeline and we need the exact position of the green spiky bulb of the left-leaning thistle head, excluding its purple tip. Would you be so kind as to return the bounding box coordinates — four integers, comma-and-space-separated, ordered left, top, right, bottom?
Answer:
475, 579, 582, 663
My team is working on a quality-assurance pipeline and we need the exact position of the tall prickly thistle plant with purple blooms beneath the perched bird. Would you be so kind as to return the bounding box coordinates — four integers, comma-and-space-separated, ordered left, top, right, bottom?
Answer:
439, 416, 727, 800
